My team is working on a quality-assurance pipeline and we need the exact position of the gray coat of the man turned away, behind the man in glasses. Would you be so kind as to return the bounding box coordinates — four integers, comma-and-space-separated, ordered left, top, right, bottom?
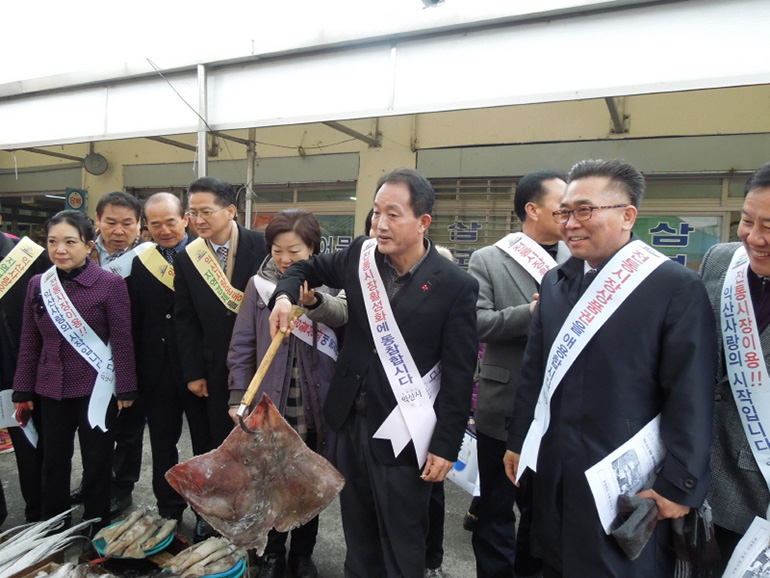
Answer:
468, 236, 570, 441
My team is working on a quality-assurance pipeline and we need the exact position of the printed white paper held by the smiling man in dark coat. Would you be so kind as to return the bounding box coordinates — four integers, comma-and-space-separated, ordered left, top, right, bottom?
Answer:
586, 415, 666, 534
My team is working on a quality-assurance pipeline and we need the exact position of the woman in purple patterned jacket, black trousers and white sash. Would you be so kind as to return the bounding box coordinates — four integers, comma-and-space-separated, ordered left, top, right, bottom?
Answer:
13, 211, 137, 529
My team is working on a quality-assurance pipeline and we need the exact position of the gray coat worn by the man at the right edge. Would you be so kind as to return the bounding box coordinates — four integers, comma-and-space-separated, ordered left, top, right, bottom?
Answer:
701, 243, 770, 534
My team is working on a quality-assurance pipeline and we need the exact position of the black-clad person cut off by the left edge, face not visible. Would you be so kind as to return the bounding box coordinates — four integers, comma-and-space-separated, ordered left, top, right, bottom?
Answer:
0, 217, 51, 523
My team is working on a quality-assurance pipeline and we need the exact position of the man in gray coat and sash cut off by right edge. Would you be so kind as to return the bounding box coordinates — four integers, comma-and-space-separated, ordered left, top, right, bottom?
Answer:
701, 163, 770, 566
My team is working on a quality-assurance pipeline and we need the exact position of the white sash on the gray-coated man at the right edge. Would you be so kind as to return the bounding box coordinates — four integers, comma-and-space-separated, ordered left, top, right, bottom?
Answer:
719, 246, 770, 504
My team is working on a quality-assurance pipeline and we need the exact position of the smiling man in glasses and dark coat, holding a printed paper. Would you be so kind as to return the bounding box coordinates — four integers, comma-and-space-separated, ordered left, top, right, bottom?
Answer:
505, 160, 716, 578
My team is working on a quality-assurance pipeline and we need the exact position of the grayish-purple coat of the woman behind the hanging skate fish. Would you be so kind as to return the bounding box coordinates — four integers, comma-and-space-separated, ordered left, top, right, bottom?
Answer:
227, 257, 336, 463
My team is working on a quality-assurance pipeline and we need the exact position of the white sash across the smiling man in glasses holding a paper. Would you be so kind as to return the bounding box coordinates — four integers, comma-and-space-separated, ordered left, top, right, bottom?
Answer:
518, 240, 668, 477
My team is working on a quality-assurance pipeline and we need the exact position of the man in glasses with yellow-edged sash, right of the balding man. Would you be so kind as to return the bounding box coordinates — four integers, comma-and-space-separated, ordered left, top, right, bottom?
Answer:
174, 177, 267, 538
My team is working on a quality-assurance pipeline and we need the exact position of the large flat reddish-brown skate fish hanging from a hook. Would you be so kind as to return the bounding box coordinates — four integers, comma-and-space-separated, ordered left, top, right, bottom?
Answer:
166, 395, 345, 555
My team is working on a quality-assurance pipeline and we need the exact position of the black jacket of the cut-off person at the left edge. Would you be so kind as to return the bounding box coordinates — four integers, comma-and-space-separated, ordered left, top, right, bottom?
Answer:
0, 233, 51, 389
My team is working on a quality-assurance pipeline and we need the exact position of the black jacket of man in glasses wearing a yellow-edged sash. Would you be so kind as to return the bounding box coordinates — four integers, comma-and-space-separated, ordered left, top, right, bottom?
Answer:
174, 225, 267, 388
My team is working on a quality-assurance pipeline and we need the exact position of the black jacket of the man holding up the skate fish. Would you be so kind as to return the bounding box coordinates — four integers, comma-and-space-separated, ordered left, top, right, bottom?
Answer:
271, 237, 478, 465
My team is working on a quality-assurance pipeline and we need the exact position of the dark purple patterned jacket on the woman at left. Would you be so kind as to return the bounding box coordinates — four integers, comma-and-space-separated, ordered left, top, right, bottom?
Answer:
13, 259, 136, 401
